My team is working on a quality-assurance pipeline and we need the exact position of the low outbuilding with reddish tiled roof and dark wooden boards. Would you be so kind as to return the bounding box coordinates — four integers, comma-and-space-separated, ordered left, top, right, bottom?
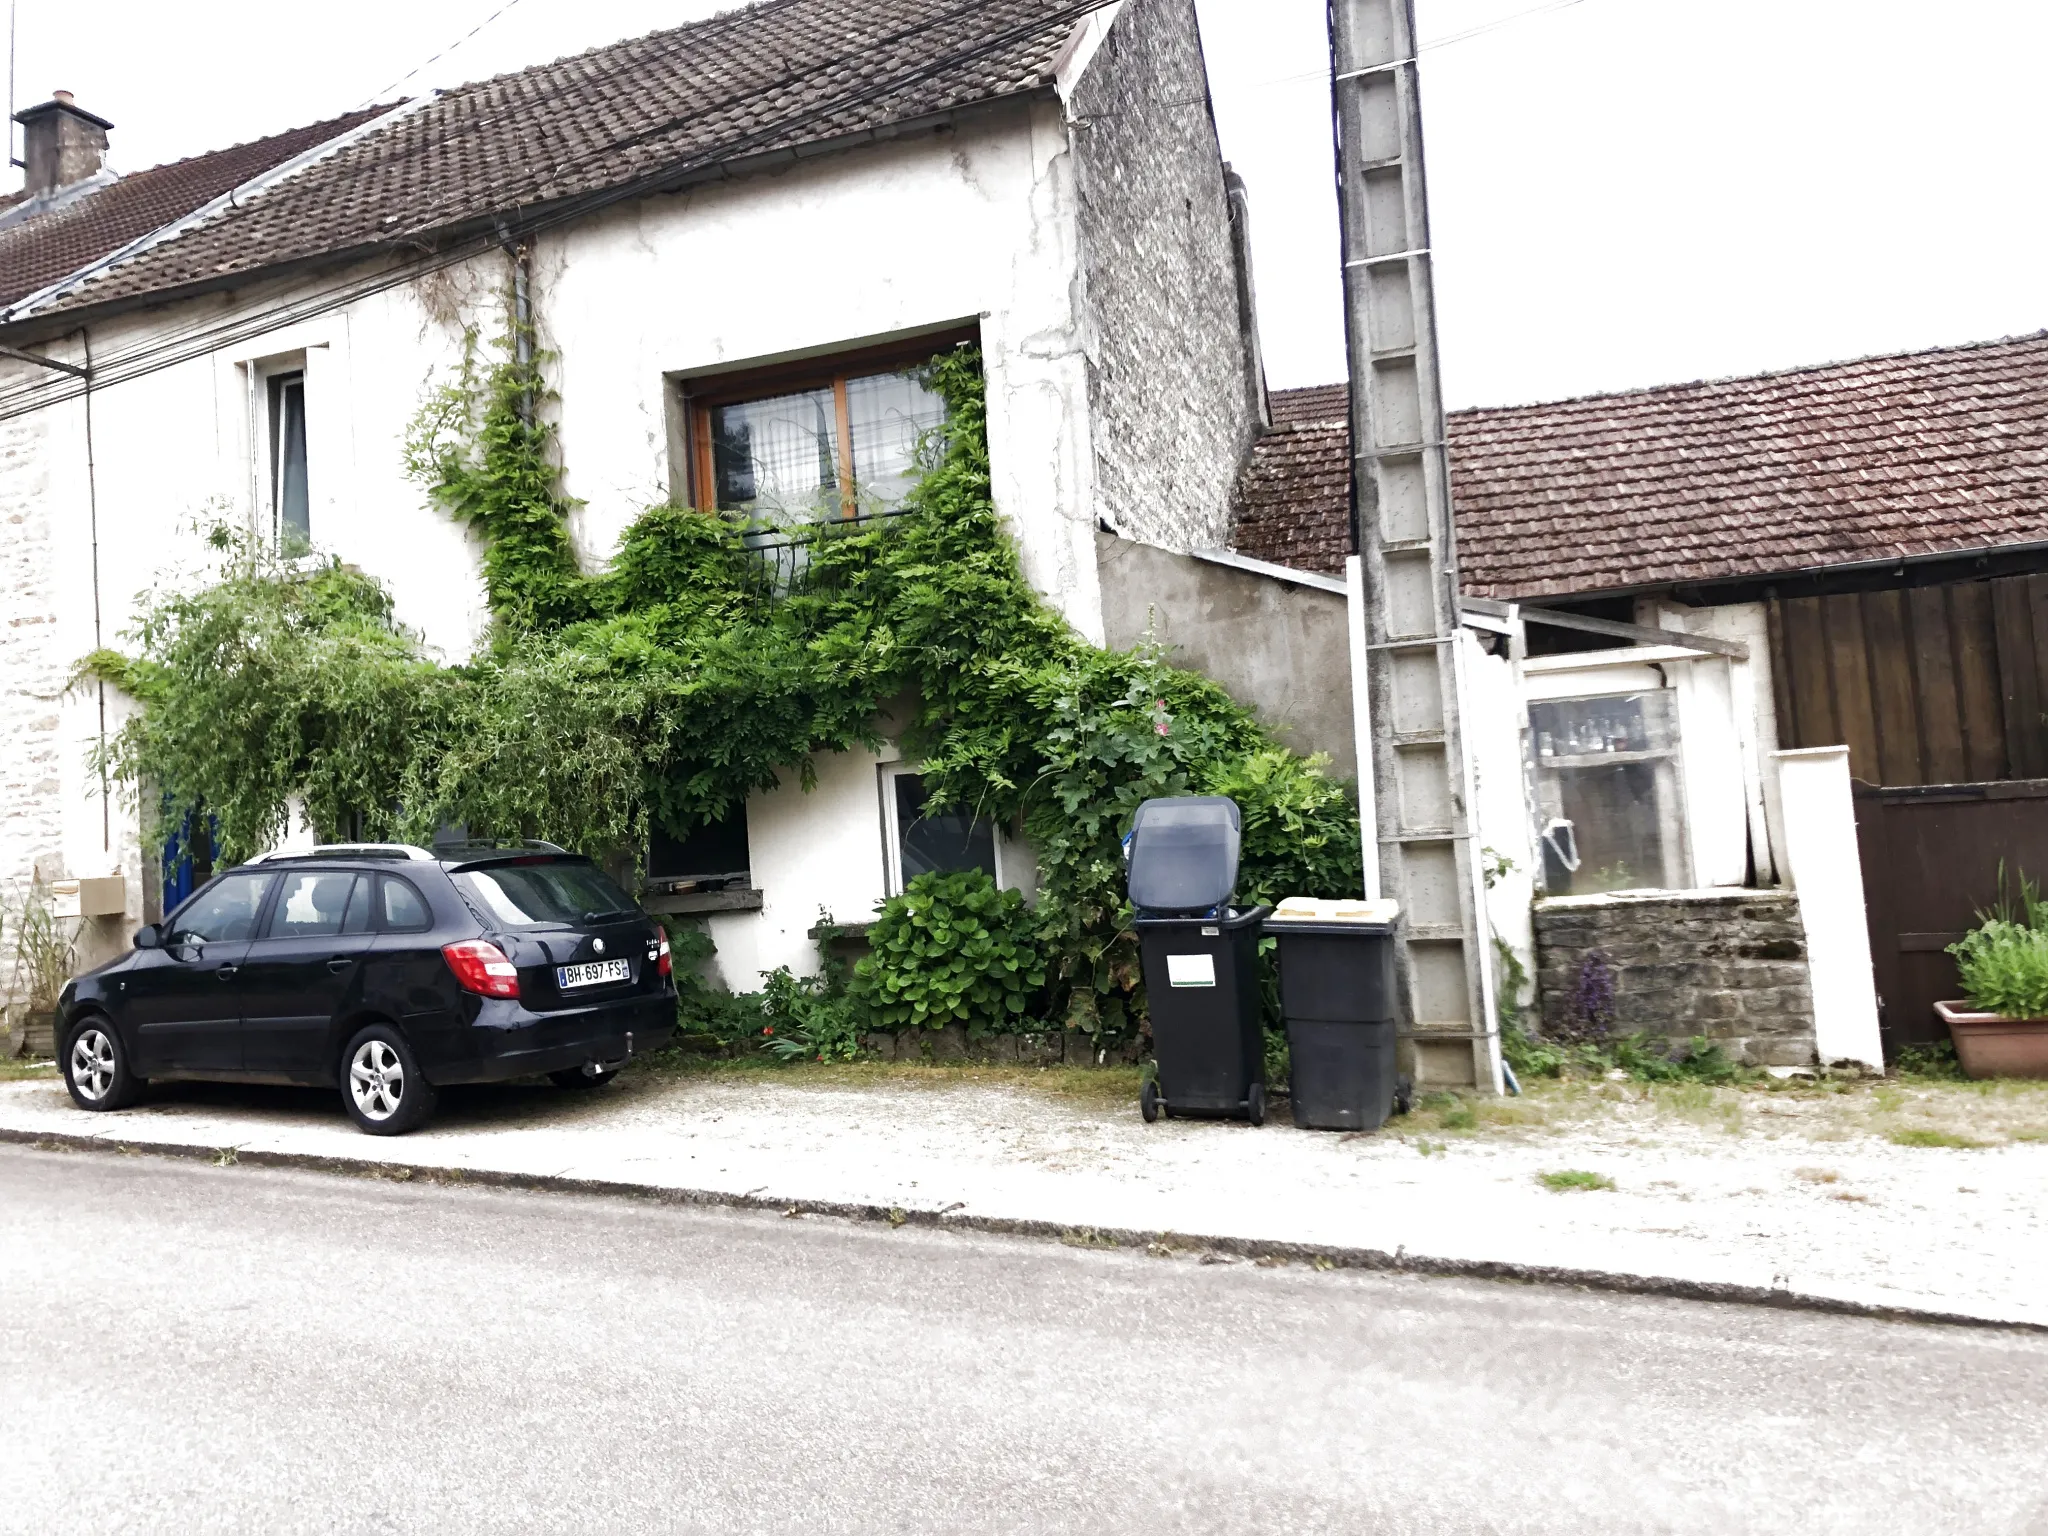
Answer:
1233, 334, 2048, 1065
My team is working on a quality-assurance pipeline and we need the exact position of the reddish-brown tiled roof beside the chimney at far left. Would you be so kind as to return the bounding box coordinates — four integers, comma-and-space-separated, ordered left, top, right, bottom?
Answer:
0, 106, 387, 305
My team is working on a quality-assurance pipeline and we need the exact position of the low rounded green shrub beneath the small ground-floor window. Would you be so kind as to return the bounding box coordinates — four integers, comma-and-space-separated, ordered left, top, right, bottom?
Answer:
852, 870, 1047, 1036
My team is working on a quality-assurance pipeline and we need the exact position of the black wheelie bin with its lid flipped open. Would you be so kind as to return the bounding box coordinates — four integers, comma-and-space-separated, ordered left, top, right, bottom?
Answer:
1128, 795, 1268, 1124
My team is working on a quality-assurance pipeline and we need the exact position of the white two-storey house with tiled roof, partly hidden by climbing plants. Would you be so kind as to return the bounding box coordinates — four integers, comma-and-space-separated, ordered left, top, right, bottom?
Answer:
0, 0, 1302, 987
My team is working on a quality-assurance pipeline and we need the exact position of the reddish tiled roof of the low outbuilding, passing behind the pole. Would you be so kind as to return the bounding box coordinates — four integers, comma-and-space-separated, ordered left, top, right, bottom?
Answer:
1237, 334, 2048, 598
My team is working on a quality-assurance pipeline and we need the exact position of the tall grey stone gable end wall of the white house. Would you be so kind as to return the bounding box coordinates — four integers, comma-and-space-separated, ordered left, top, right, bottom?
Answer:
1069, 0, 1262, 549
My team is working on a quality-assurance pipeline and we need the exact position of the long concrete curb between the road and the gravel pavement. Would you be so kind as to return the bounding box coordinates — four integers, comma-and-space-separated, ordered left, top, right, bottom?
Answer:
0, 1126, 2048, 1333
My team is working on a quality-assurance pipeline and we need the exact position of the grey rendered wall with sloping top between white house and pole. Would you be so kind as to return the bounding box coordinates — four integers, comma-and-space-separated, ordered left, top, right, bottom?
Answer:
1096, 532, 1358, 778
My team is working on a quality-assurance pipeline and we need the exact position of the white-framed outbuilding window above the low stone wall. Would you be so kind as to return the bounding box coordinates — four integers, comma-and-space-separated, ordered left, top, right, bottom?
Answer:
1528, 690, 1690, 895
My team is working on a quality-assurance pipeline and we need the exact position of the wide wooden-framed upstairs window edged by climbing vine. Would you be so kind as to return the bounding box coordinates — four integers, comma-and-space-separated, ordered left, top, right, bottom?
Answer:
688, 336, 958, 522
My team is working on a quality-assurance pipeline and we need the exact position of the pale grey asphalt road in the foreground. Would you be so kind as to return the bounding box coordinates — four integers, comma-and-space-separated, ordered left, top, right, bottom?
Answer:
0, 1147, 2048, 1536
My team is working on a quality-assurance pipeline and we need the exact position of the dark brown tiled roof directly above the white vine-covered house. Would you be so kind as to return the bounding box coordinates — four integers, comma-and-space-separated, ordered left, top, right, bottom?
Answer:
4, 0, 1102, 325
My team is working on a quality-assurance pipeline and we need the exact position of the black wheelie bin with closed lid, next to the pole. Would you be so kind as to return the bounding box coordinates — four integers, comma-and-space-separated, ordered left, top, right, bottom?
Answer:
1266, 897, 1407, 1130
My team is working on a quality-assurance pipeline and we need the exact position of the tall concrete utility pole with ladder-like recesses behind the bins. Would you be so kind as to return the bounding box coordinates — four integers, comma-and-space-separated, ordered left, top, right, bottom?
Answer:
1329, 0, 1501, 1092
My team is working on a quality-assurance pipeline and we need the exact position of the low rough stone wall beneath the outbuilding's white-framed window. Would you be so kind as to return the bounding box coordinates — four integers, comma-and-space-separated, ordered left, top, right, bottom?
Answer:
1534, 891, 1815, 1067
